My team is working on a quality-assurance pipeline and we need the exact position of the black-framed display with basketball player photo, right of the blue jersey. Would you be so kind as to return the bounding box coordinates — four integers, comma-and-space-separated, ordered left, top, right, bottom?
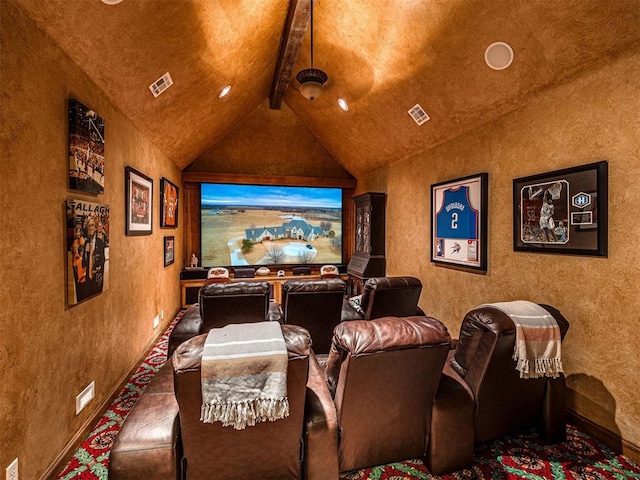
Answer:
513, 161, 608, 257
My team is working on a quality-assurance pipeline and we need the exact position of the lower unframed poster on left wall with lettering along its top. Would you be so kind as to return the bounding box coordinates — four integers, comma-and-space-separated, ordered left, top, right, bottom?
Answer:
67, 200, 109, 305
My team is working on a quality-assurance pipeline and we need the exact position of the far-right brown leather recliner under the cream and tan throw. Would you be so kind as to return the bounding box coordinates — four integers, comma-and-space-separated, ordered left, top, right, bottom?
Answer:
427, 305, 569, 472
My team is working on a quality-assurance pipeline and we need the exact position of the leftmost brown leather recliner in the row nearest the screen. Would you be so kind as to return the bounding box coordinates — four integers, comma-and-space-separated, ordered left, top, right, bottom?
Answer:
167, 281, 280, 357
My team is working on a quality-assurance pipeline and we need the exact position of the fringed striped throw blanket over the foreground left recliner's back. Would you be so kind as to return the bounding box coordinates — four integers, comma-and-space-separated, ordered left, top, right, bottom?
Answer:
200, 322, 289, 430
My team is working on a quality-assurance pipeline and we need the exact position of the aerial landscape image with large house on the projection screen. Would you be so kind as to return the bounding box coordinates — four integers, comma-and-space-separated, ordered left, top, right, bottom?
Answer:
200, 183, 342, 267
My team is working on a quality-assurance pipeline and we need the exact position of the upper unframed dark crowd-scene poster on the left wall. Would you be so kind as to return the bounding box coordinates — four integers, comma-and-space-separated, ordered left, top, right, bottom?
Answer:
69, 98, 104, 194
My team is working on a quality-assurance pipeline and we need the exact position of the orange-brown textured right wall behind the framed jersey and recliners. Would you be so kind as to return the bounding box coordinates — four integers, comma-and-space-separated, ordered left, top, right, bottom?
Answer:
359, 47, 640, 446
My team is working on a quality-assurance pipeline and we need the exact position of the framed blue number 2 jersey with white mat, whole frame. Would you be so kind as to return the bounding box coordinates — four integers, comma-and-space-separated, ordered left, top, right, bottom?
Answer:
431, 173, 489, 273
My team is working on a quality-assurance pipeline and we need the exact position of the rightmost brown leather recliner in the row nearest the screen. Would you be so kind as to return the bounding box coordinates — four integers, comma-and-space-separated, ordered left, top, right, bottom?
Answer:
342, 277, 424, 321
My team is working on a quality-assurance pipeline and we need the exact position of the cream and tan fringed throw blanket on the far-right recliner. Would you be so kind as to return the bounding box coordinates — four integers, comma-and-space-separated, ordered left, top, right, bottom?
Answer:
481, 300, 562, 378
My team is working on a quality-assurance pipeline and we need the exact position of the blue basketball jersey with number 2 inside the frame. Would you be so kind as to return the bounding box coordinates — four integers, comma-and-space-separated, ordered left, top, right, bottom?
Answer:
436, 187, 478, 240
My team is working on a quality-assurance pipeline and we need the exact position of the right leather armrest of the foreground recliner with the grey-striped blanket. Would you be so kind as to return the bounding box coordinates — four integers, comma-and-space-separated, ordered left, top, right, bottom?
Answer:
304, 352, 338, 480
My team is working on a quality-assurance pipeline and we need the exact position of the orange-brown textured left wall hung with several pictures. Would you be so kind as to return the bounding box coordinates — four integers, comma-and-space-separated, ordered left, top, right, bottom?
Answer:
0, 2, 183, 479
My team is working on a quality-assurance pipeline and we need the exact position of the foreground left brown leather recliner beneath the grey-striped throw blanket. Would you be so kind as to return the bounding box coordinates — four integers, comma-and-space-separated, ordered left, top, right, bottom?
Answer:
173, 325, 337, 480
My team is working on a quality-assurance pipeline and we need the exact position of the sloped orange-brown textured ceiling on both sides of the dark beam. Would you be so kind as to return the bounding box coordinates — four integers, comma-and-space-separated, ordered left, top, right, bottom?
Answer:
12, 0, 640, 176
